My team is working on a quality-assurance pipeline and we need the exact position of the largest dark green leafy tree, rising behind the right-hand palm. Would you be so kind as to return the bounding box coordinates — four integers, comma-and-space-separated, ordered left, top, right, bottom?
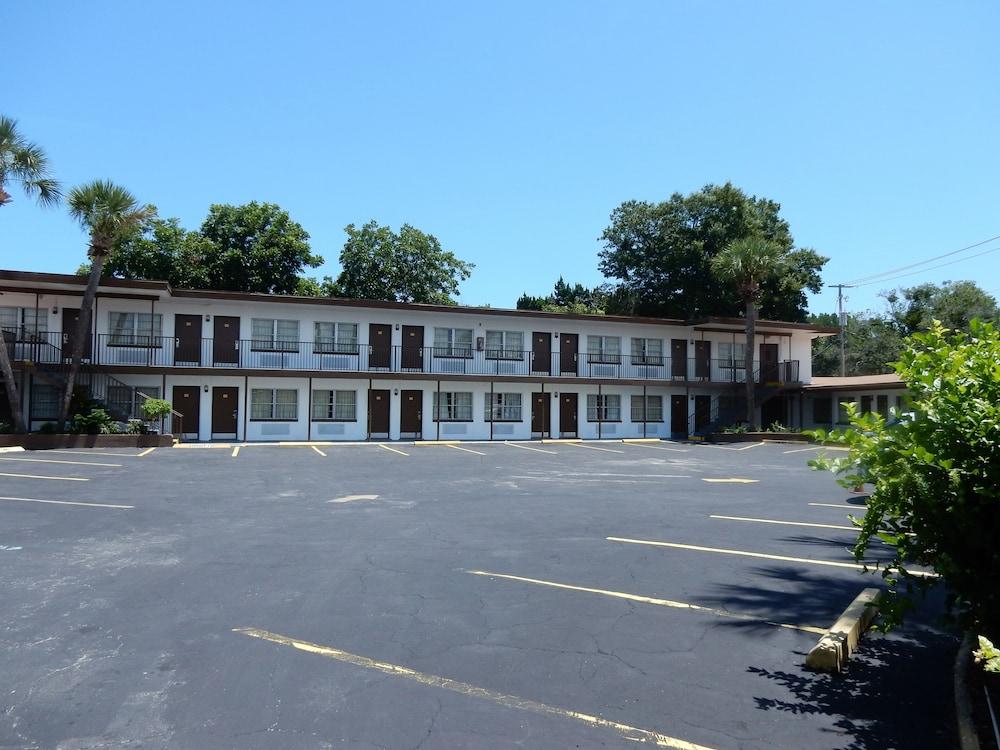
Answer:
599, 183, 827, 321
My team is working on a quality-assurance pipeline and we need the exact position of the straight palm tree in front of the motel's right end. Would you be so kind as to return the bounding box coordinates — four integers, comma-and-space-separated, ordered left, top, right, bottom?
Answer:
712, 236, 784, 427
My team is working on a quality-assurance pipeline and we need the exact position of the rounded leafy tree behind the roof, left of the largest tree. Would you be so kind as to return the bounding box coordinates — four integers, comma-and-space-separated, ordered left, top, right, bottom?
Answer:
327, 221, 475, 305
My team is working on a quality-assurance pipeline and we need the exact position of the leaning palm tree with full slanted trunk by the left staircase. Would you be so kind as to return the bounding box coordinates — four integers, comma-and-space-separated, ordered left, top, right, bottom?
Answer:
58, 180, 154, 432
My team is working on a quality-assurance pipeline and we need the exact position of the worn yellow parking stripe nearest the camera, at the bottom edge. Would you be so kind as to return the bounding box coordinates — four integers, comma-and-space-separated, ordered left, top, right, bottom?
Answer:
233, 628, 711, 750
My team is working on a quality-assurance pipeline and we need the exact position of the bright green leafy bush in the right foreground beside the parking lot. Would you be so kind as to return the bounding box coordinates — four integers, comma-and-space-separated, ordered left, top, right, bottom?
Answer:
810, 321, 1000, 634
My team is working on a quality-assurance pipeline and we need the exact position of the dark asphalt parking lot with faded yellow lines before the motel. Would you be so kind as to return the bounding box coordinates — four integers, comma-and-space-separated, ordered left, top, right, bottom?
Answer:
0, 442, 954, 750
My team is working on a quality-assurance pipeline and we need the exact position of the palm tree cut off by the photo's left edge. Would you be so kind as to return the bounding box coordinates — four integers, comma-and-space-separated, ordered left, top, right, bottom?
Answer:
0, 115, 62, 432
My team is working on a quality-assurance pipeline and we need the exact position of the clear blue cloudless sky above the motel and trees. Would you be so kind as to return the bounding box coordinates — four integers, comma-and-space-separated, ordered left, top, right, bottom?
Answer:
0, 0, 1000, 318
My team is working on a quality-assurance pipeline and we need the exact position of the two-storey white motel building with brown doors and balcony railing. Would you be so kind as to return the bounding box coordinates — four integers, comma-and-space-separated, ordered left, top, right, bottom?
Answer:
0, 271, 834, 441
